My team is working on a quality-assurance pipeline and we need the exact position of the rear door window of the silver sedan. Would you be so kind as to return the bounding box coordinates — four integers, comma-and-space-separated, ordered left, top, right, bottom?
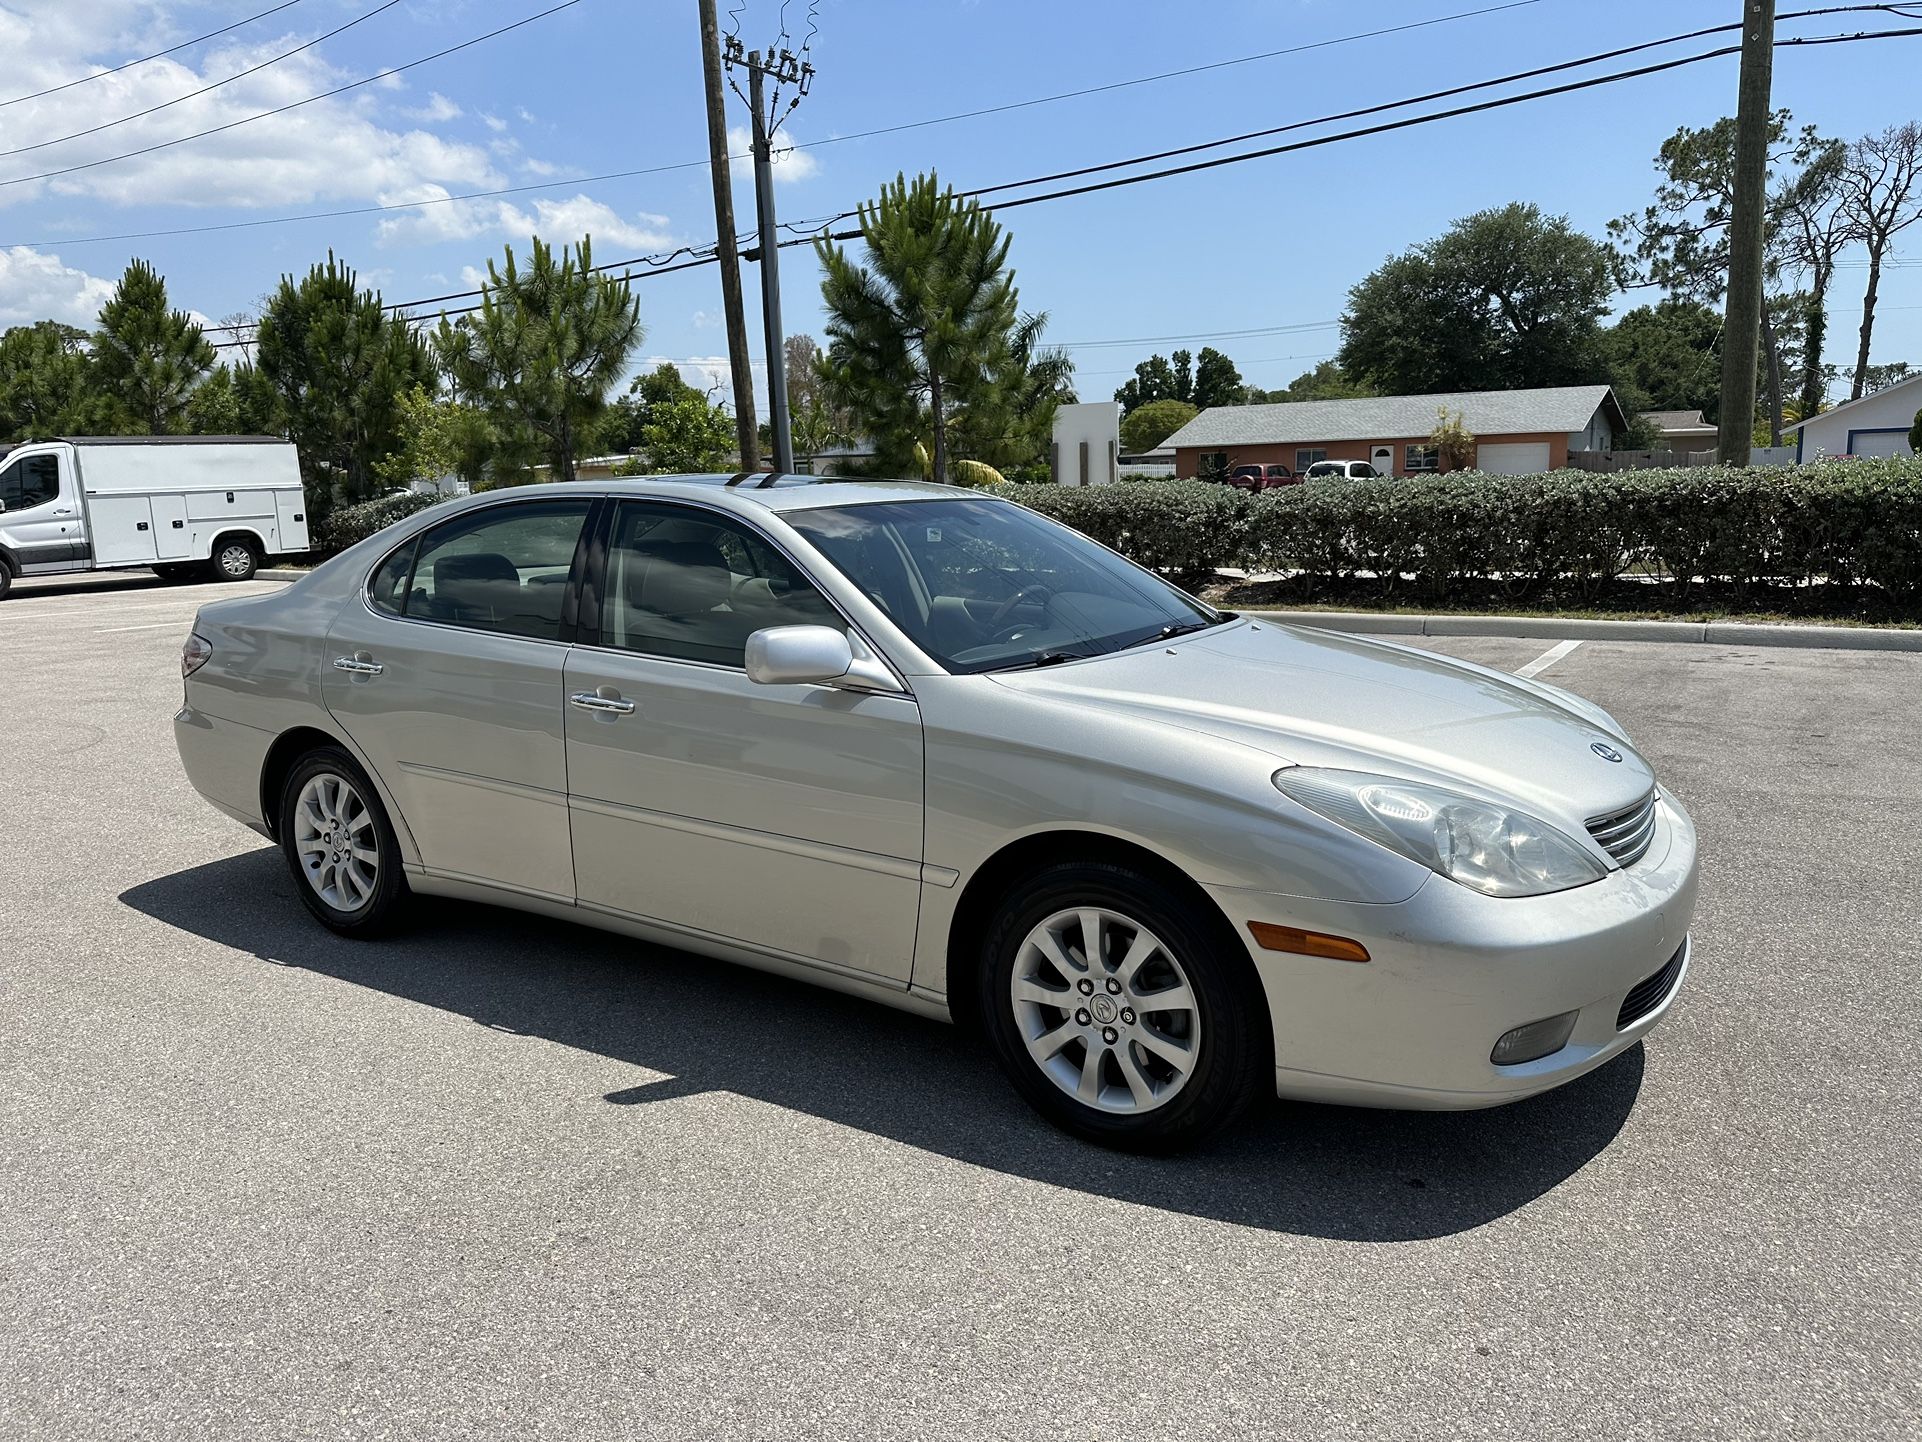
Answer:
394, 500, 590, 640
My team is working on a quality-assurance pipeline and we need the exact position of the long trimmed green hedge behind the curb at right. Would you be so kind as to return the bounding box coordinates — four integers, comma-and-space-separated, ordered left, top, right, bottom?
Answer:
1013, 458, 1922, 596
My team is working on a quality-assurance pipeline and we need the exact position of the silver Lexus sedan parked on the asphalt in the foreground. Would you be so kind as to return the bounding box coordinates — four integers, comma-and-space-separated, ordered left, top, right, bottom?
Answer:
175, 475, 1695, 1148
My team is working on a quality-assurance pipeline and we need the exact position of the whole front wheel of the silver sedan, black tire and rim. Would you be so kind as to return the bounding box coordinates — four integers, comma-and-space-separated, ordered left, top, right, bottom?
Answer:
976, 861, 1274, 1152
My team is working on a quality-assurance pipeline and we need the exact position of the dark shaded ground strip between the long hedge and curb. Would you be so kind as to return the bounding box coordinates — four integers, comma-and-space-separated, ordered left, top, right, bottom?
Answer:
1197, 577, 1922, 629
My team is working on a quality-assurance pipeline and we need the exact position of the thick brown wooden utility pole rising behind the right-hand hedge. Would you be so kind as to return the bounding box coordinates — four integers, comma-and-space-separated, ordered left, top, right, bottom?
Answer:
1714, 0, 1776, 465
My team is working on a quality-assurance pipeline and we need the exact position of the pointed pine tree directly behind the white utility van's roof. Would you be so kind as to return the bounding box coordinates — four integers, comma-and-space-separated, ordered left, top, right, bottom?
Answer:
92, 260, 213, 436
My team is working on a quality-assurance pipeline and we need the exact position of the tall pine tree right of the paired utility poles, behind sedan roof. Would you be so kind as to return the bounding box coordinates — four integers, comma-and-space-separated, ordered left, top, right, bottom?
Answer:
817, 173, 1017, 483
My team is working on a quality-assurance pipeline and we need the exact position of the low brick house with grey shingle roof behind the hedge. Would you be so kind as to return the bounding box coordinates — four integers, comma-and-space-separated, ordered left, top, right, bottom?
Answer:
1161, 385, 1628, 477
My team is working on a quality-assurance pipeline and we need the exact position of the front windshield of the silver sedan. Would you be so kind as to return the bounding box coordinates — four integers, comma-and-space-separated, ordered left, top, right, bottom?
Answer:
782, 496, 1226, 673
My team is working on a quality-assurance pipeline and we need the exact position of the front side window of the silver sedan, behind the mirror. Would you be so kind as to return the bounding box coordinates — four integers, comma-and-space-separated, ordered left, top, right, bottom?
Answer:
600, 502, 846, 665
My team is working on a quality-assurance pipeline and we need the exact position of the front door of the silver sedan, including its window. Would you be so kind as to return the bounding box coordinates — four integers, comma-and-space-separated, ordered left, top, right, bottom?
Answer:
565, 502, 923, 986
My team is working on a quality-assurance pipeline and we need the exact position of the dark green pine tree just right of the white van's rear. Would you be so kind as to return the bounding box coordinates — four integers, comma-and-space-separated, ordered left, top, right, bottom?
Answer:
255, 252, 438, 515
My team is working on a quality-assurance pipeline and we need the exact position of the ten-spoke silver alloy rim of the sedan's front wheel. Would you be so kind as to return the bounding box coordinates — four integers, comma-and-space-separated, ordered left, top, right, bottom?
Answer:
1009, 906, 1201, 1115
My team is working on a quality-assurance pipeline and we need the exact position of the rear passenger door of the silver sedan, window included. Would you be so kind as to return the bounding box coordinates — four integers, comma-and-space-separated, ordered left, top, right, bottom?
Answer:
321, 500, 592, 902
